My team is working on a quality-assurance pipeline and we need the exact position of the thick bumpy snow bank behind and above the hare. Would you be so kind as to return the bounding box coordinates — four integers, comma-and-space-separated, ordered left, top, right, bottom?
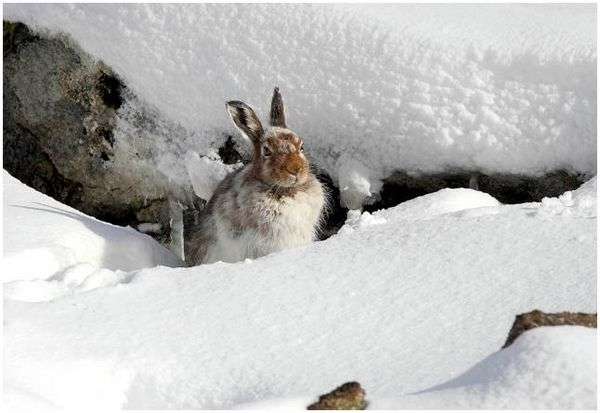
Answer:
4, 4, 597, 203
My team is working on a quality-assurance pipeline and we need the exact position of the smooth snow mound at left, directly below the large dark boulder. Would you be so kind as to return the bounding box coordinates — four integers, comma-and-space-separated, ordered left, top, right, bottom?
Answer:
2, 171, 178, 288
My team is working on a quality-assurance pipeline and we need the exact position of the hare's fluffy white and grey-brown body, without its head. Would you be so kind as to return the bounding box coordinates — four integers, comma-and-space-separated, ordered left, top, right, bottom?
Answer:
186, 165, 324, 264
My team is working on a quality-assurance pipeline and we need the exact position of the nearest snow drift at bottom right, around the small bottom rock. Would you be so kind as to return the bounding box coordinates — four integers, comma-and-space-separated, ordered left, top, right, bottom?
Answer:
234, 326, 597, 411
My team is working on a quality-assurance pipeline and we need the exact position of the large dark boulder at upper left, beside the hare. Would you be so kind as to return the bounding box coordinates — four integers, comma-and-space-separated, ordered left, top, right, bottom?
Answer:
3, 21, 183, 238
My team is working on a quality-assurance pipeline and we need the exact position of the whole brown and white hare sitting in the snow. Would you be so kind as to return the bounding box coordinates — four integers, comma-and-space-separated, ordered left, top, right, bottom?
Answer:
186, 88, 326, 265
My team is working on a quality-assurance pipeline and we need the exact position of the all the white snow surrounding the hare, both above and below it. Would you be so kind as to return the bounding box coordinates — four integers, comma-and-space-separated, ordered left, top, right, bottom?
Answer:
2, 4, 597, 411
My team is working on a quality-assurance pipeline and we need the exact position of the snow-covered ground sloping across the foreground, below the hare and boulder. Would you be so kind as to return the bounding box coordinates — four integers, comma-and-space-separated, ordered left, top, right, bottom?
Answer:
3, 173, 596, 411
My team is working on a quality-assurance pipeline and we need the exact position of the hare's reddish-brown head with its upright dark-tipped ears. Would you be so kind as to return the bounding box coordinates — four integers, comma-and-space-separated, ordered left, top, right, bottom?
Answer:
227, 88, 310, 187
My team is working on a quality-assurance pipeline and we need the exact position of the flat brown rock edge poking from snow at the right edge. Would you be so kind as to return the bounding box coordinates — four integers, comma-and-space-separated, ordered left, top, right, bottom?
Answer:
502, 310, 597, 348
